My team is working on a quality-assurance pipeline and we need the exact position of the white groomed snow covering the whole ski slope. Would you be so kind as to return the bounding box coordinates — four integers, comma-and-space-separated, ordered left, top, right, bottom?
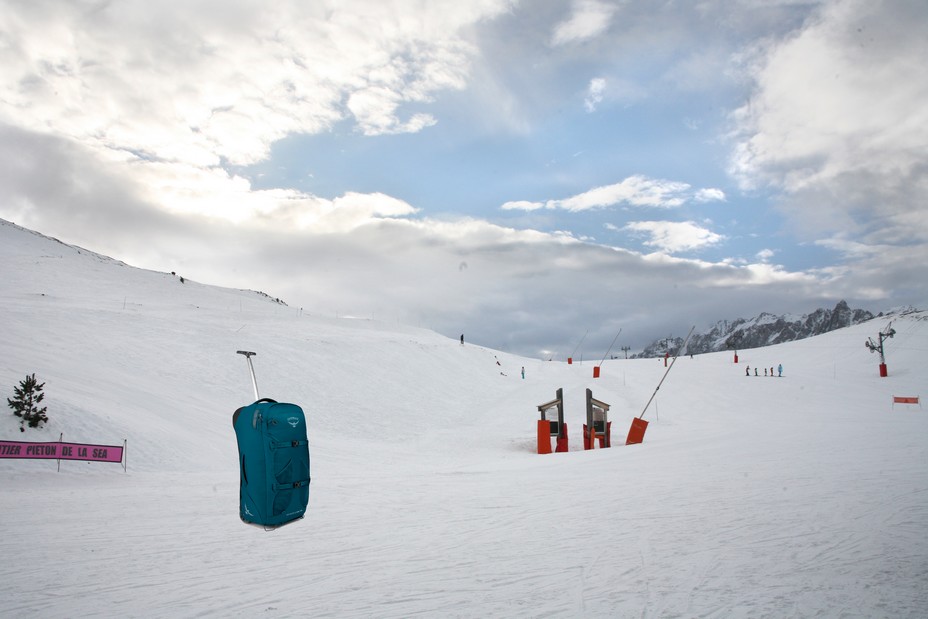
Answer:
0, 222, 928, 618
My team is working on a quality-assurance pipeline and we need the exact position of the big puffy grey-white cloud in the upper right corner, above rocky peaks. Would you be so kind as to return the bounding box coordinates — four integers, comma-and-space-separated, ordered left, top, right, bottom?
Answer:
731, 0, 928, 240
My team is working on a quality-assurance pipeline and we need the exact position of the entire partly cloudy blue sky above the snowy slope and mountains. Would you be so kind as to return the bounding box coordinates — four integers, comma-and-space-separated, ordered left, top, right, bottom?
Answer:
0, 0, 928, 359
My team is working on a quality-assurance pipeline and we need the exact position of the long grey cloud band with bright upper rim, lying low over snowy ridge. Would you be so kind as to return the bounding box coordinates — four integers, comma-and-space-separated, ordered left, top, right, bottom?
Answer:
0, 120, 840, 356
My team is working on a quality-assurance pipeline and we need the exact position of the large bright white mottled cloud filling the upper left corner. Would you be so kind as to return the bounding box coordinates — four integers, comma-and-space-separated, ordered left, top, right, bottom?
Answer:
0, 0, 507, 167
